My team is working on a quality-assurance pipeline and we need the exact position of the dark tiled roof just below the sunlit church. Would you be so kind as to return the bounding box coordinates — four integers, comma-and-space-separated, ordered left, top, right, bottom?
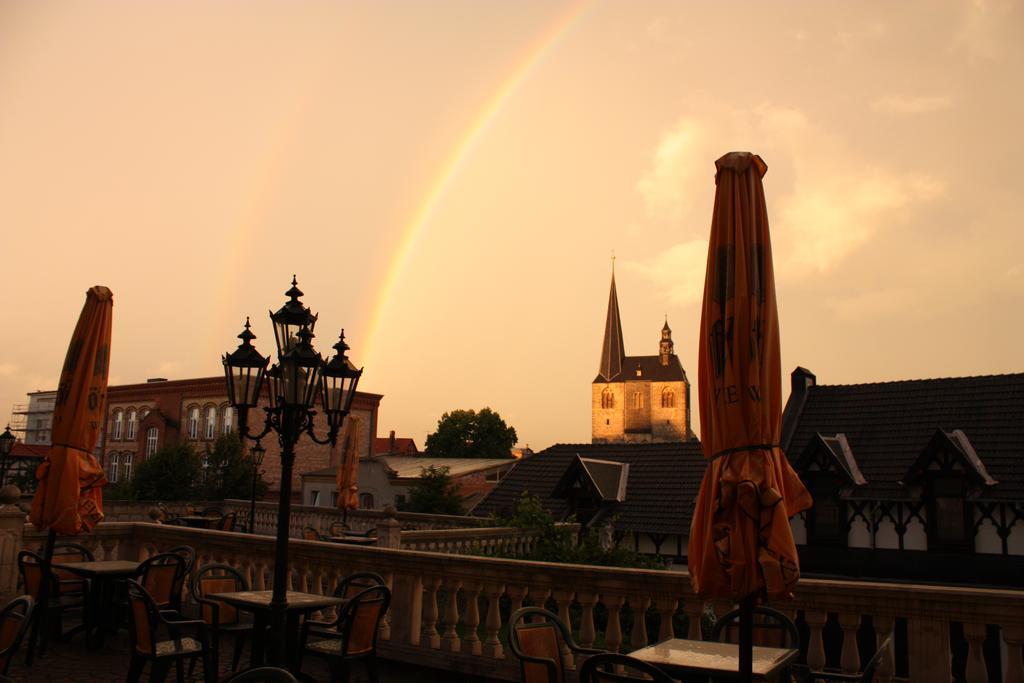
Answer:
473, 440, 705, 536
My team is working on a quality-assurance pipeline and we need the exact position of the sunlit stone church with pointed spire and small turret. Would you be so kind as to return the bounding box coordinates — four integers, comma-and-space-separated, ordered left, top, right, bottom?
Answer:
591, 270, 693, 443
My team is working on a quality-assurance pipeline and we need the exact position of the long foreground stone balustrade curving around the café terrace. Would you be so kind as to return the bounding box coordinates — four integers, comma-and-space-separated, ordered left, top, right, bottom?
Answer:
8, 522, 1024, 683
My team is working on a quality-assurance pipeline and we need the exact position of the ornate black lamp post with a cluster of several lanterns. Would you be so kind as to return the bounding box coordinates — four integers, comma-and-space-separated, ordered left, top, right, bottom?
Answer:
223, 276, 362, 665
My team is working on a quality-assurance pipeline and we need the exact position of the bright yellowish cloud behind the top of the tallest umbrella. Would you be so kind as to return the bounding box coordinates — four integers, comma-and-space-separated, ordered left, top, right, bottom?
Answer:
636, 102, 945, 290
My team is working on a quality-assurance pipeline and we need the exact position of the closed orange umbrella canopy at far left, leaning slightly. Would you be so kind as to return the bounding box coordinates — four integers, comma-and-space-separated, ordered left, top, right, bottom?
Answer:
30, 287, 114, 536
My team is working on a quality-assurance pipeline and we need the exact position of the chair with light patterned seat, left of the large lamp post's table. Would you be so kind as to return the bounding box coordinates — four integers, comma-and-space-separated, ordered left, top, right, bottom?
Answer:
125, 579, 217, 683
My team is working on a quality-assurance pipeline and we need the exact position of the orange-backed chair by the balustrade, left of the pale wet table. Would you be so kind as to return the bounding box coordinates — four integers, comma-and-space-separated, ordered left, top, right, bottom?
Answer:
509, 607, 604, 683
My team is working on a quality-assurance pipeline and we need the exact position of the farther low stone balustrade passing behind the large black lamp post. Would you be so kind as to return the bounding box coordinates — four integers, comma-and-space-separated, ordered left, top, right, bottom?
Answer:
222, 499, 489, 539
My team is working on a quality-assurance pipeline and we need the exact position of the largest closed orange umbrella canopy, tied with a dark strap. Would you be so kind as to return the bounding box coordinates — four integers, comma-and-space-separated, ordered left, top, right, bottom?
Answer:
689, 152, 811, 600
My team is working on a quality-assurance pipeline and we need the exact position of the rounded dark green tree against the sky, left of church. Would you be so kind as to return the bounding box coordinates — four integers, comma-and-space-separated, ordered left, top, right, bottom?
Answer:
424, 408, 517, 458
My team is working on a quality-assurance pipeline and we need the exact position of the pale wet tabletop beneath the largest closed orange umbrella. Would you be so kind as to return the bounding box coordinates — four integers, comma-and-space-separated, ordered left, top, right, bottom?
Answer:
630, 638, 800, 681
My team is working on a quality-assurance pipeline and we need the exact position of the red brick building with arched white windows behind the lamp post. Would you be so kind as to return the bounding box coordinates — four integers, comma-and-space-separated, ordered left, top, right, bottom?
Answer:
97, 377, 383, 499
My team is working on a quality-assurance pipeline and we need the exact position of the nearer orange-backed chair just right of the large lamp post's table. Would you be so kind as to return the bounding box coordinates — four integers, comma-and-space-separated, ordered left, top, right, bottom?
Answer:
299, 586, 391, 683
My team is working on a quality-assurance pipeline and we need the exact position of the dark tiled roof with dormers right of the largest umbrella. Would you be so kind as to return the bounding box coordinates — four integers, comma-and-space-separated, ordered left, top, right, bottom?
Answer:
782, 374, 1024, 501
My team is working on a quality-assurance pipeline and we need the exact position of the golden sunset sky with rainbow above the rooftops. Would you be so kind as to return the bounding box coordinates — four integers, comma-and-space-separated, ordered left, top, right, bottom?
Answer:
0, 0, 1024, 450
